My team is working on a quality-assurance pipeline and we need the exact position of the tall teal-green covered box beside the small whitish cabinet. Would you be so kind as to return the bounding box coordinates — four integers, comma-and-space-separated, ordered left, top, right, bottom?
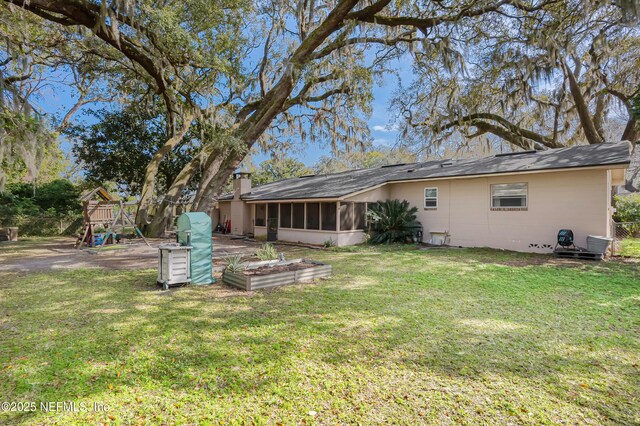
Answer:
177, 212, 216, 284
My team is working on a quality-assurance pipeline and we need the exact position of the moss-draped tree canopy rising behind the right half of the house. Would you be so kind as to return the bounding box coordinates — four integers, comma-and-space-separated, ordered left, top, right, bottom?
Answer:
394, 1, 640, 156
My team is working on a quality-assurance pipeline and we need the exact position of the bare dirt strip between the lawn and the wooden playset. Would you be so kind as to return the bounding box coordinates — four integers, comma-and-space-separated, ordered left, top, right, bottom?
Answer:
0, 236, 268, 272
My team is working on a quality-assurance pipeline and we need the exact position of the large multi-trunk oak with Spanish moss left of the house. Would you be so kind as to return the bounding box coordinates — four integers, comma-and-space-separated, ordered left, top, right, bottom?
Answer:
5, 0, 556, 234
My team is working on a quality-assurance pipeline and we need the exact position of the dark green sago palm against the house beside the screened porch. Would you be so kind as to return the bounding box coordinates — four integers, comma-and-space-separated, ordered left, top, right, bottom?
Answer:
367, 200, 422, 244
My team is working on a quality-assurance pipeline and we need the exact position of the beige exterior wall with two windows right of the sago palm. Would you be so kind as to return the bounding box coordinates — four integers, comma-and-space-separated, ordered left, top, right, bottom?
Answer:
389, 170, 611, 253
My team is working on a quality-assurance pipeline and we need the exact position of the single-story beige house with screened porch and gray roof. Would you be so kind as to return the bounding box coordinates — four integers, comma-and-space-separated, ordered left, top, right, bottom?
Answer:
212, 142, 631, 252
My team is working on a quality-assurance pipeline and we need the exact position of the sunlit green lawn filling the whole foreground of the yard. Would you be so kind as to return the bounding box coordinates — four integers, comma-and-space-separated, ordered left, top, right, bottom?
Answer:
0, 247, 640, 425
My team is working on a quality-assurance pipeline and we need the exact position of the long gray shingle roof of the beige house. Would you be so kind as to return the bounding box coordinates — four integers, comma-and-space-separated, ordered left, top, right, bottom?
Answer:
220, 142, 630, 200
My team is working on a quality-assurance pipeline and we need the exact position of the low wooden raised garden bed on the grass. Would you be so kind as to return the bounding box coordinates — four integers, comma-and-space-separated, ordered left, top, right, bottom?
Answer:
222, 259, 332, 291
